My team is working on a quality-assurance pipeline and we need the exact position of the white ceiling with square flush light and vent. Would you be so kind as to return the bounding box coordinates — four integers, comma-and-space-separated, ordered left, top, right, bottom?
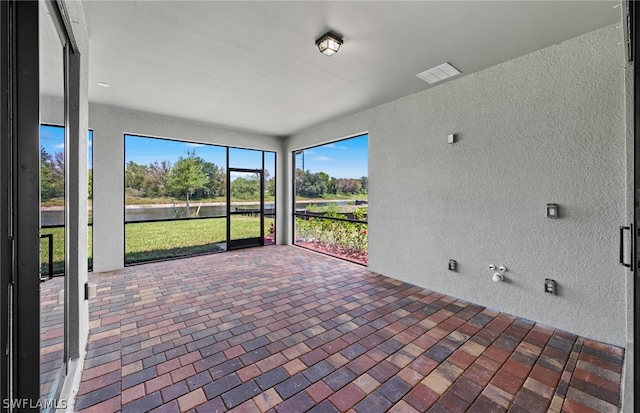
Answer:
84, 1, 622, 136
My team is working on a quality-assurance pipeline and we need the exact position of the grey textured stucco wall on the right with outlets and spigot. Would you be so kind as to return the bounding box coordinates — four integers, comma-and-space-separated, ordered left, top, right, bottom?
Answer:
287, 26, 627, 346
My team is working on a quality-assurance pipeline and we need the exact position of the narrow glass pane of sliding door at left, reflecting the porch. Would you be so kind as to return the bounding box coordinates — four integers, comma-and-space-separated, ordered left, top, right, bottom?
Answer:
39, 1, 68, 402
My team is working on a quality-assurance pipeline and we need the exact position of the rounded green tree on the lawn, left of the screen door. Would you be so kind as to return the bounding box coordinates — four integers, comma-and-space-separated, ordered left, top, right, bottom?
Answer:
167, 150, 209, 216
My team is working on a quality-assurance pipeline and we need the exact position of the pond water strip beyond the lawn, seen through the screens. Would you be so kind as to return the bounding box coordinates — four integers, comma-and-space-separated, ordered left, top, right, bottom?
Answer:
40, 201, 349, 227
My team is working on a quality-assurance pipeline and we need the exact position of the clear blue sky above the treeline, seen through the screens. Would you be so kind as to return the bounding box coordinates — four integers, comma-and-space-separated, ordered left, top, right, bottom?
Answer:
40, 125, 369, 178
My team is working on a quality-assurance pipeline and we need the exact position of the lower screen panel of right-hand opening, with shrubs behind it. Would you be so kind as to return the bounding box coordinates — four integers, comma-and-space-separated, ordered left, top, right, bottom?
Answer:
294, 212, 369, 265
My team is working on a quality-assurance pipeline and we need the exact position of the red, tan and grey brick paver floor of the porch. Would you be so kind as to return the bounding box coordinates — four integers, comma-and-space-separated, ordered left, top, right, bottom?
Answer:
67, 246, 624, 413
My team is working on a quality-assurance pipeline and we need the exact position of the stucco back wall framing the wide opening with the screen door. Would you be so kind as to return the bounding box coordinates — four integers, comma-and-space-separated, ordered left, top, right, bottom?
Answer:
89, 104, 284, 272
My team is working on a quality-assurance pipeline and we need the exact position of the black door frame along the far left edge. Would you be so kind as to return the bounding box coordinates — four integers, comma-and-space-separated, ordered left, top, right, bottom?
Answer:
0, 1, 40, 411
